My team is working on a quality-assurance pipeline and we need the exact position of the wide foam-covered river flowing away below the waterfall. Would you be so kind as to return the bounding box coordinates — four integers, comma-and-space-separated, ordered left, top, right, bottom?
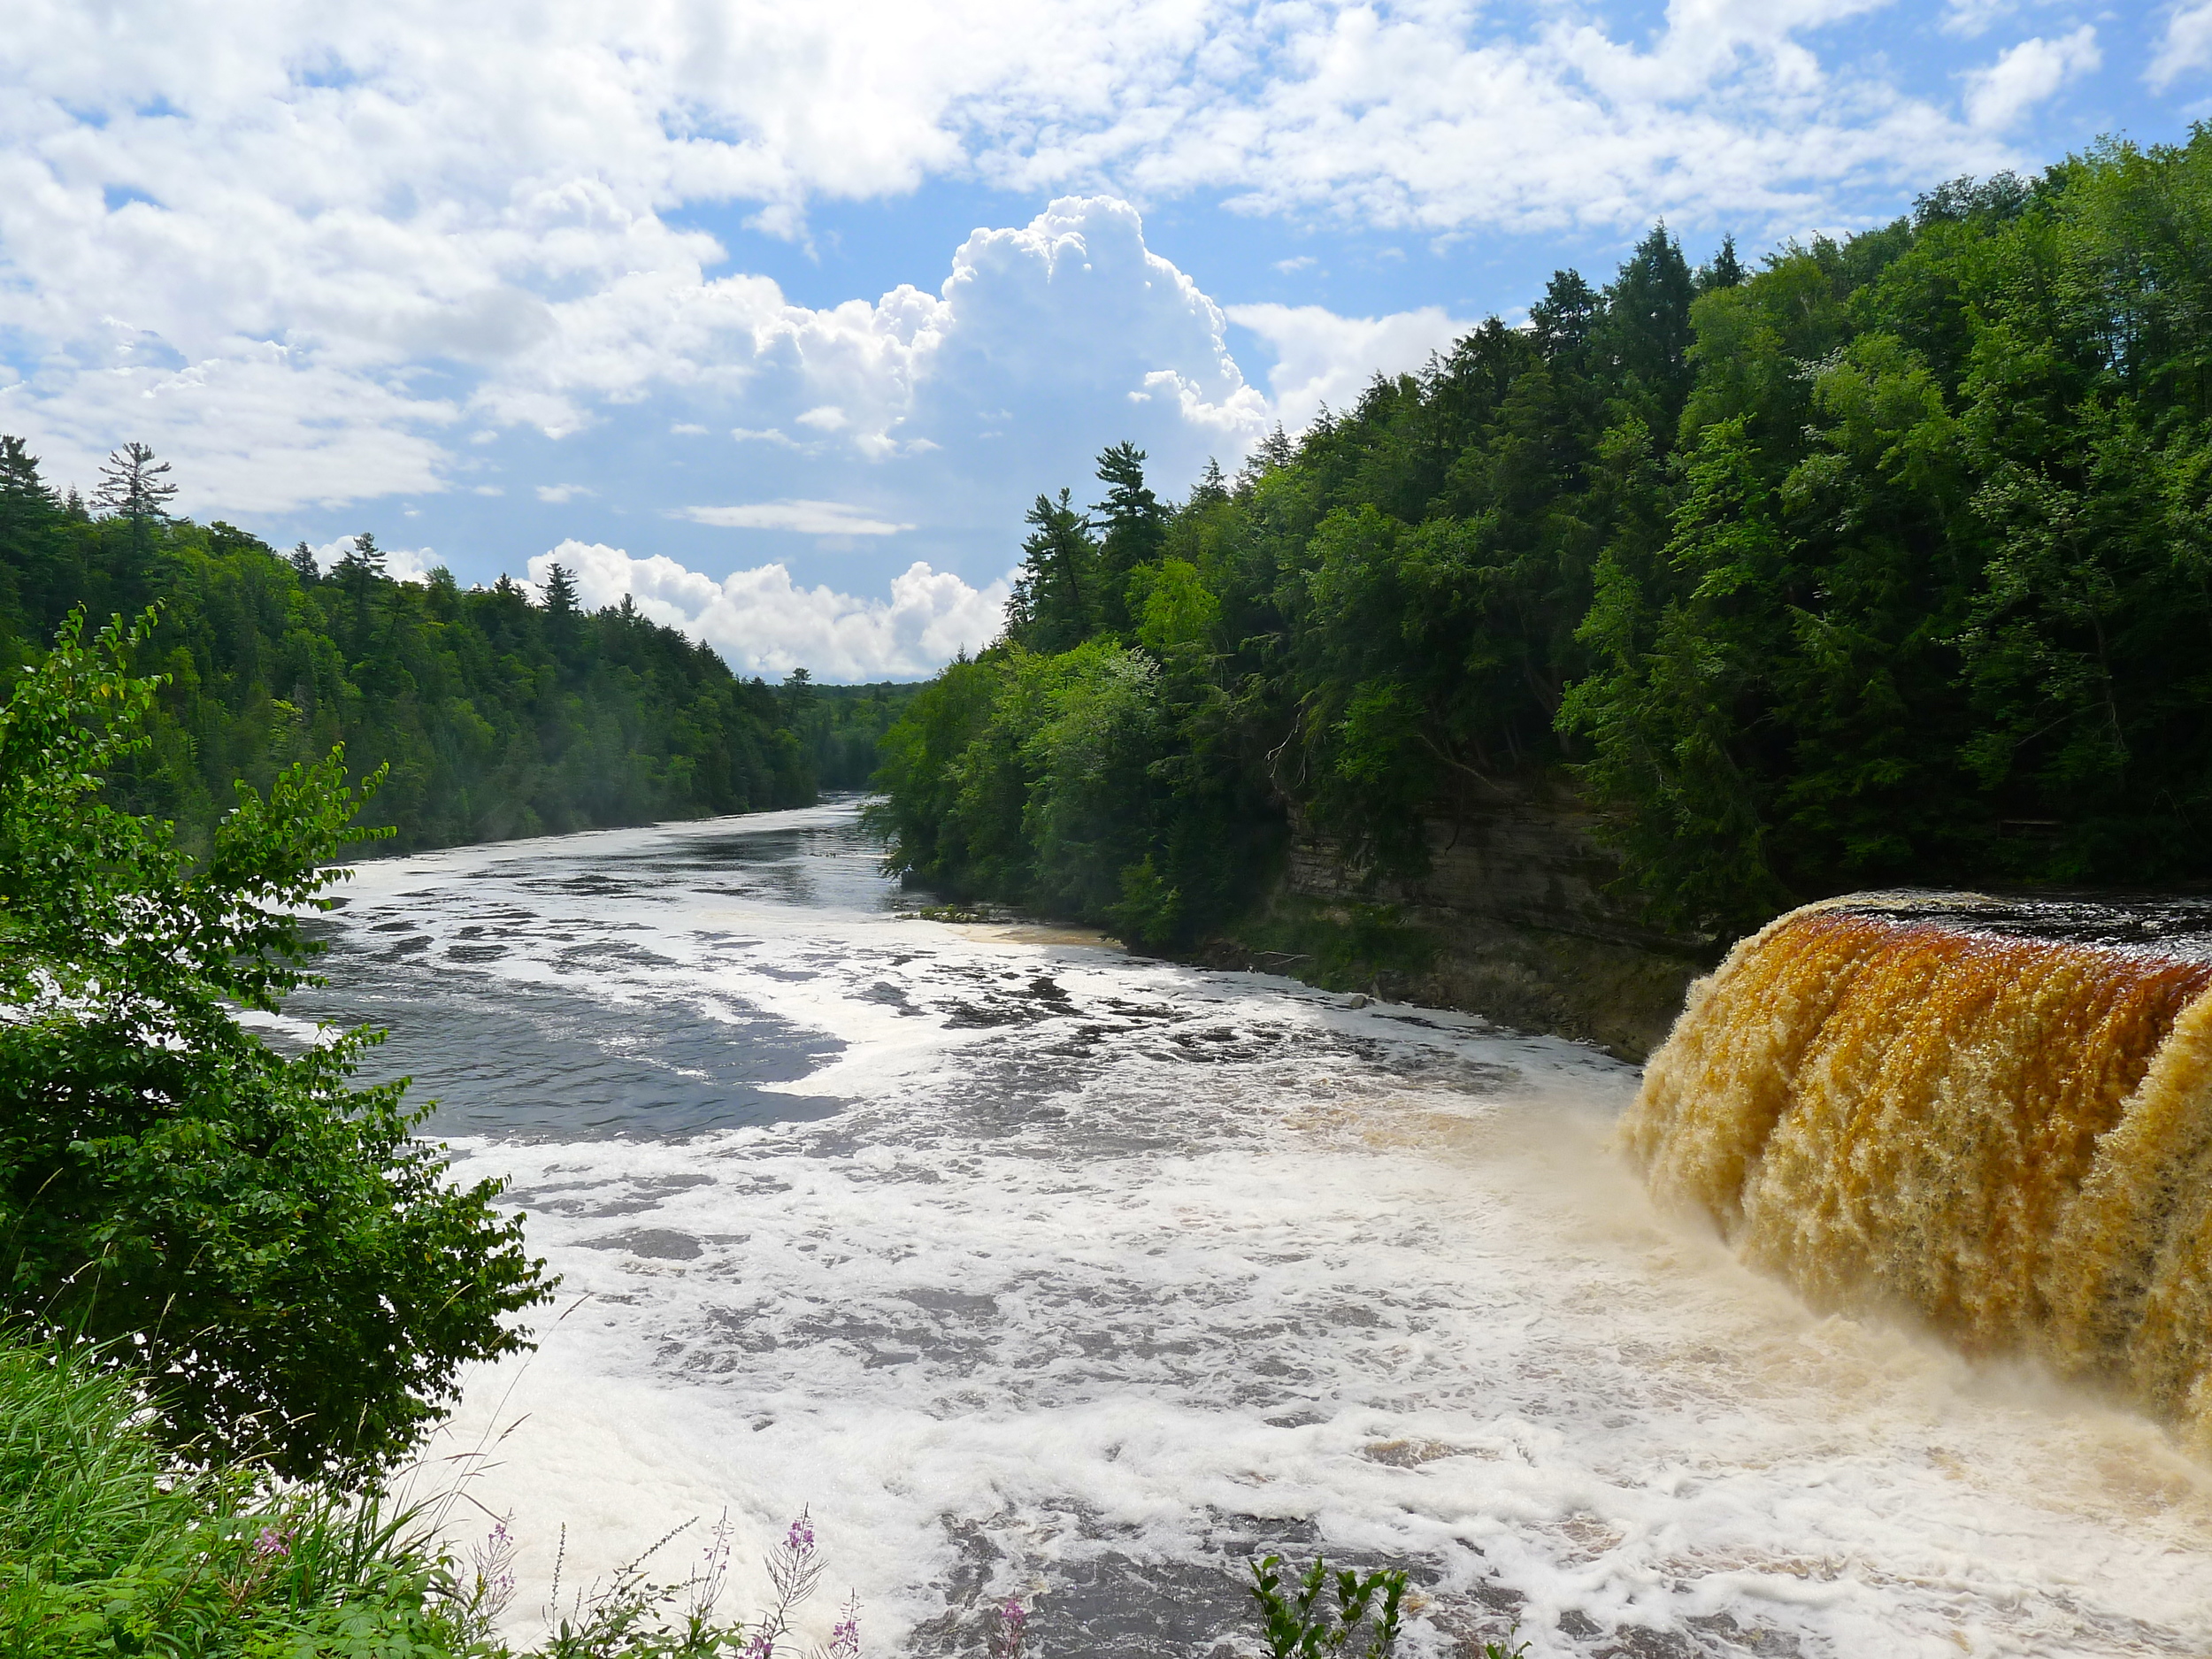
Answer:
295, 808, 2212, 1659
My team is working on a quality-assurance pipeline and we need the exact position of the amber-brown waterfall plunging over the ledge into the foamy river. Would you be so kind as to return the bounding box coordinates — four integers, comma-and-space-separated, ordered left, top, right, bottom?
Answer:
1619, 894, 2212, 1451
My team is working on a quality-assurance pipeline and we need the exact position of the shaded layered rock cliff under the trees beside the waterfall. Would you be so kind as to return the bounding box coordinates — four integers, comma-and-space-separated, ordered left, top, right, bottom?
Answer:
1208, 786, 1715, 1062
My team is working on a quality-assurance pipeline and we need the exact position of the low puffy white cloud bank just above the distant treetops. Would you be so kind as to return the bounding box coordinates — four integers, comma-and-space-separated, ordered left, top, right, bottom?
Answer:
531, 542, 1011, 681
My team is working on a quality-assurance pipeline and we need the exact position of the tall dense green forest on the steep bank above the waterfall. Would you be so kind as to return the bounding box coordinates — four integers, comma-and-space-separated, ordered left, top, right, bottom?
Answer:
883, 128, 2212, 945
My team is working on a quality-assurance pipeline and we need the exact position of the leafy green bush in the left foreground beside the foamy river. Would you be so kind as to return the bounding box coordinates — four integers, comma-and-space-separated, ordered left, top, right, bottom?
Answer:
0, 613, 549, 1480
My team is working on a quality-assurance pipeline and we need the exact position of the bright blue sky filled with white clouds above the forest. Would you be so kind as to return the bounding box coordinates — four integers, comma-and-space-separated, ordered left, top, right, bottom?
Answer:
0, 0, 2212, 681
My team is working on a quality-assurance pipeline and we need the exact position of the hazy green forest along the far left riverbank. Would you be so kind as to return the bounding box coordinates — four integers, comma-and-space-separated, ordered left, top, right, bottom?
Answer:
0, 438, 814, 849
